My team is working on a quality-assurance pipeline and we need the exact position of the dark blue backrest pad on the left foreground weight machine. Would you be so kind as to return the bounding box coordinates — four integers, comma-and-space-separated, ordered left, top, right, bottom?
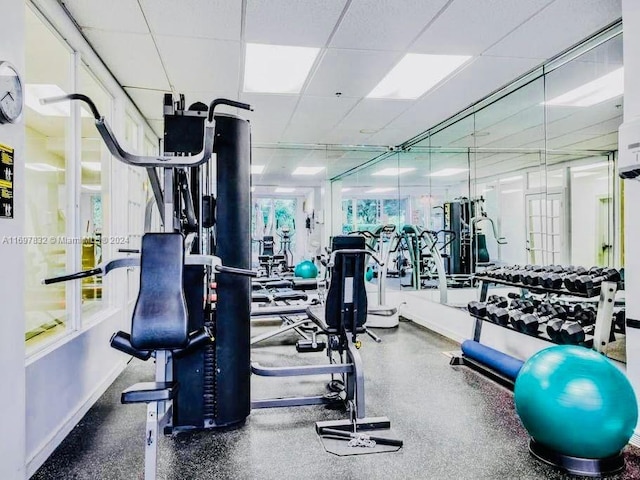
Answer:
131, 233, 189, 350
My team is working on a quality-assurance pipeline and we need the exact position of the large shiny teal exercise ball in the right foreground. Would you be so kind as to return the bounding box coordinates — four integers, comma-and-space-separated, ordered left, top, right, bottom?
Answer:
514, 345, 638, 459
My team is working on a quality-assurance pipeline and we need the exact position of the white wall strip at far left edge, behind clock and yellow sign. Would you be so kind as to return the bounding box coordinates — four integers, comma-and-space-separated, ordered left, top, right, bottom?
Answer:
0, 0, 25, 480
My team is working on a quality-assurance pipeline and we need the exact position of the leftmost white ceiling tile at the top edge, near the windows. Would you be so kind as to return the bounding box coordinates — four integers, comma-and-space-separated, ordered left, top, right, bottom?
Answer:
64, 0, 149, 33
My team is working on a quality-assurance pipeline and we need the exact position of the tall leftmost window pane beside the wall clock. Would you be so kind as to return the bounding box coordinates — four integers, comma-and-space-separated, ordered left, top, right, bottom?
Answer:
24, 8, 75, 351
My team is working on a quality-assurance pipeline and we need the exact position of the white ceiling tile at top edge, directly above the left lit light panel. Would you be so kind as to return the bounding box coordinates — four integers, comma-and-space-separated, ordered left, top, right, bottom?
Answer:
245, 0, 346, 47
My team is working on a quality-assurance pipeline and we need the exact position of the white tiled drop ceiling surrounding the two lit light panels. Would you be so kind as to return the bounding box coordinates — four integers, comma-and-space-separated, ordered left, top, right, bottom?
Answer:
57, 0, 621, 181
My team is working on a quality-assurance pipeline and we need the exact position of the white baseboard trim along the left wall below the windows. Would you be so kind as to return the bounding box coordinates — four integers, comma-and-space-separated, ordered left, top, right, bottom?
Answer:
26, 361, 127, 478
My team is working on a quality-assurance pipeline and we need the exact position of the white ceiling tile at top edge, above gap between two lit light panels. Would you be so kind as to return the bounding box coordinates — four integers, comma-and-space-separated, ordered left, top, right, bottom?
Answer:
330, 0, 447, 51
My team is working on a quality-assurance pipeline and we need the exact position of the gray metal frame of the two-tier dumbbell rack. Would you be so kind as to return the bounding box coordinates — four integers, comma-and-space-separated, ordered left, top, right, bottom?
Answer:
471, 275, 618, 353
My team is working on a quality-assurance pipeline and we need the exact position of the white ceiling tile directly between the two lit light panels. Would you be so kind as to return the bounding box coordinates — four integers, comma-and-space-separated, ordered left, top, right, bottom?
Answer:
305, 48, 402, 97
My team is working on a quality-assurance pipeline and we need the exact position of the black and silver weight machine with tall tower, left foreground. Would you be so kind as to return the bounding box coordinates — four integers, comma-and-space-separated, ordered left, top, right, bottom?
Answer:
38, 94, 256, 479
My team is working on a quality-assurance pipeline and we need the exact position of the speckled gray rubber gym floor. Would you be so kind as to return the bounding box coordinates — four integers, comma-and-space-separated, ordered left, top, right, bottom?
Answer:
32, 322, 640, 480
